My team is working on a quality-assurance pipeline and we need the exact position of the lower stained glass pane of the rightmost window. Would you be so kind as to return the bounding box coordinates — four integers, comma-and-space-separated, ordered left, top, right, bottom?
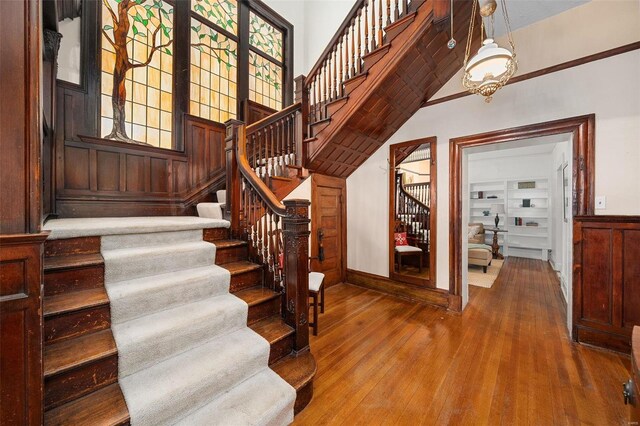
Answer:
249, 52, 282, 110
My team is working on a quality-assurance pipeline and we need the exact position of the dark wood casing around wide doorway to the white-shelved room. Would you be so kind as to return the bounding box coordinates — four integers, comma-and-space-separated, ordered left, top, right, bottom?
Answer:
449, 114, 595, 312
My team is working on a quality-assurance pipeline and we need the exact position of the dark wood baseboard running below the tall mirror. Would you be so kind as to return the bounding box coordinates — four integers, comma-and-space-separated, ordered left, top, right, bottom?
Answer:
347, 269, 451, 309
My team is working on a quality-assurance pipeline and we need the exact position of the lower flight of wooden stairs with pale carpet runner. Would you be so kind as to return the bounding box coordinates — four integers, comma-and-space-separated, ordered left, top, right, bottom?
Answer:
44, 217, 315, 425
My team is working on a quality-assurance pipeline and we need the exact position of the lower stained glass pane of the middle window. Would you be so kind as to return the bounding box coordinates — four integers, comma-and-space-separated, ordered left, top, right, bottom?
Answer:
189, 18, 238, 123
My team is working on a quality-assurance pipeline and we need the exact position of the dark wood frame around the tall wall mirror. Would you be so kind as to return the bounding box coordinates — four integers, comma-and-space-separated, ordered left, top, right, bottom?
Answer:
388, 136, 438, 288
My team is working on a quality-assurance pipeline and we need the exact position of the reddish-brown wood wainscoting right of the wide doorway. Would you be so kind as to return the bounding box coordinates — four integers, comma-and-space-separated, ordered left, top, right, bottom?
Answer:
573, 216, 640, 353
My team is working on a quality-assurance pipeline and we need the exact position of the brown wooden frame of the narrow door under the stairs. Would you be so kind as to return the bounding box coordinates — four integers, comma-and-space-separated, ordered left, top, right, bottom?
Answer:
311, 173, 347, 282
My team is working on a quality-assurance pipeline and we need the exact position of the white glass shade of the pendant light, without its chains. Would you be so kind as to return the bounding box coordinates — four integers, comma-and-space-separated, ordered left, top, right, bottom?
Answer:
462, 38, 518, 102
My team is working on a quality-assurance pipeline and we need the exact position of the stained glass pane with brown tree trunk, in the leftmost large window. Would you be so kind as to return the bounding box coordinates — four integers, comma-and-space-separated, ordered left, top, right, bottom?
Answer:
101, 0, 173, 148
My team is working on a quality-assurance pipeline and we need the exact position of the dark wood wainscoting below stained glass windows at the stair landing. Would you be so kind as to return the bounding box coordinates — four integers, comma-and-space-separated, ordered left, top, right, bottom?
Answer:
55, 83, 226, 217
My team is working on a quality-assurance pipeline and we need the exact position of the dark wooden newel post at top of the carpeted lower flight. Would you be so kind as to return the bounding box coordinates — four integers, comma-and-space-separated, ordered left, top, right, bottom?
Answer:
224, 120, 244, 237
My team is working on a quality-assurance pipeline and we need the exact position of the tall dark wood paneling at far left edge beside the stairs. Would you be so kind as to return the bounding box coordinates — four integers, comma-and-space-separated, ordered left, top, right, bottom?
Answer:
0, 0, 47, 425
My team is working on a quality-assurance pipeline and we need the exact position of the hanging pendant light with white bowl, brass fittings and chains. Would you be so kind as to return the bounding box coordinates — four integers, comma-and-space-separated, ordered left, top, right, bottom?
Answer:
462, 0, 518, 102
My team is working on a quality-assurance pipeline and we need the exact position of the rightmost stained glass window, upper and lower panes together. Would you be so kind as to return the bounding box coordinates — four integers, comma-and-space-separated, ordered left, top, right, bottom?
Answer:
249, 12, 283, 110
